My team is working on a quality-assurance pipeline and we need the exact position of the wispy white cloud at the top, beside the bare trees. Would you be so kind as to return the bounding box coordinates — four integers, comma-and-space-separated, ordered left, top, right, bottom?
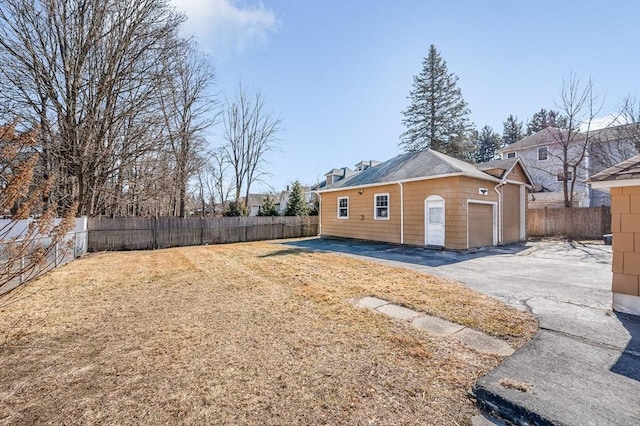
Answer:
171, 0, 280, 56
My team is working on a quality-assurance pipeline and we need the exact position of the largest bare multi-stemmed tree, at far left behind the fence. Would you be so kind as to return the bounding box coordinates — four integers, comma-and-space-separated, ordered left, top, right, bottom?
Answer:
0, 0, 209, 215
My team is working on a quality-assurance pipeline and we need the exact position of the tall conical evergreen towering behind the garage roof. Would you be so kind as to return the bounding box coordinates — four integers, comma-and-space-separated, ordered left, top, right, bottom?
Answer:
400, 45, 473, 159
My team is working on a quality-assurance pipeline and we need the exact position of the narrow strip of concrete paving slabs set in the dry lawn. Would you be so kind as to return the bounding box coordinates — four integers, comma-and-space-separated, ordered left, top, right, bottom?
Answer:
351, 296, 515, 356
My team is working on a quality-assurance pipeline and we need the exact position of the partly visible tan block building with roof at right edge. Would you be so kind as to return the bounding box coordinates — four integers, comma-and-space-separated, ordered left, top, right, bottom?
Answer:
588, 155, 640, 315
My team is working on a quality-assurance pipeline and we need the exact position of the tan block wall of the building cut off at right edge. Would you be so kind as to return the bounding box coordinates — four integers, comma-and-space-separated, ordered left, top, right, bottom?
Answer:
611, 186, 640, 302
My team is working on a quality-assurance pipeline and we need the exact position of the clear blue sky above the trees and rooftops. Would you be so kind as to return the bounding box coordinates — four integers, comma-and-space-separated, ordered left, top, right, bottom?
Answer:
172, 0, 640, 192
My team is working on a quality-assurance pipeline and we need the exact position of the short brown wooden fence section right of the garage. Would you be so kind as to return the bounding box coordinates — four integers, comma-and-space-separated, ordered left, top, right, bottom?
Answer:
527, 207, 611, 239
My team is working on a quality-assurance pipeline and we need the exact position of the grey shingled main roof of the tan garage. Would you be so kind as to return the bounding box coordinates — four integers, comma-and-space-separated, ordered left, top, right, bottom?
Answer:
324, 149, 499, 190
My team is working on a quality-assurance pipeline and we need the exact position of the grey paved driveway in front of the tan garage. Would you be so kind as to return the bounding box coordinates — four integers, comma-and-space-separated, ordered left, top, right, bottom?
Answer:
287, 238, 640, 425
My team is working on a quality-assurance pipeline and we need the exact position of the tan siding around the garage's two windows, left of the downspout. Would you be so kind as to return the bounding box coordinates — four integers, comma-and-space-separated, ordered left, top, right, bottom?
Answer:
322, 184, 400, 243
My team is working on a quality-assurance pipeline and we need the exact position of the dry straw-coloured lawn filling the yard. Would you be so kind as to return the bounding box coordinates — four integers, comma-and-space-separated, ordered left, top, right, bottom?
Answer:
0, 243, 536, 425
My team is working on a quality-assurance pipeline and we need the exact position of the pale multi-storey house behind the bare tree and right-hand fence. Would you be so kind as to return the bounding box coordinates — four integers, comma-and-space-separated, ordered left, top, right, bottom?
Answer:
498, 123, 640, 208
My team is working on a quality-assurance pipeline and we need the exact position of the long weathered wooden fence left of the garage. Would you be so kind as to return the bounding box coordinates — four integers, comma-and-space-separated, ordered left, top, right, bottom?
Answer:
88, 216, 318, 252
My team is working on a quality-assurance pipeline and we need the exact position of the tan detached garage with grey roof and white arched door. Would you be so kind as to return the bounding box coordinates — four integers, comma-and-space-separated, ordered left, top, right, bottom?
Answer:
317, 150, 531, 250
